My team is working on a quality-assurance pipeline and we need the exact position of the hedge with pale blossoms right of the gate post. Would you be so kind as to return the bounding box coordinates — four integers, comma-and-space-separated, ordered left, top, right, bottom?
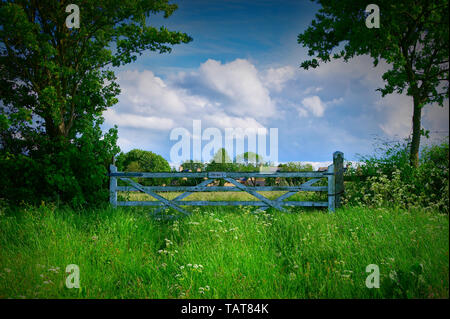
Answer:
344, 142, 449, 214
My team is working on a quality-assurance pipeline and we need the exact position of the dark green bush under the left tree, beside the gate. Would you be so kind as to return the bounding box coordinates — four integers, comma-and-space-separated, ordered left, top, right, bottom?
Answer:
0, 123, 119, 206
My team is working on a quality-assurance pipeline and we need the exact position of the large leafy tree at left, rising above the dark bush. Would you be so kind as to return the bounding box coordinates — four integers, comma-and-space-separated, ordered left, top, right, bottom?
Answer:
0, 0, 192, 141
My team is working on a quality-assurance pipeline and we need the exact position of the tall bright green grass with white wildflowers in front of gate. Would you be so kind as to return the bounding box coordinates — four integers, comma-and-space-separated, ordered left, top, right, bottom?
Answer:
0, 206, 449, 298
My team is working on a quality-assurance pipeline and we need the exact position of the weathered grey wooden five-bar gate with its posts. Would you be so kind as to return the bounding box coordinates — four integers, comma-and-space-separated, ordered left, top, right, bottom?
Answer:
109, 152, 344, 215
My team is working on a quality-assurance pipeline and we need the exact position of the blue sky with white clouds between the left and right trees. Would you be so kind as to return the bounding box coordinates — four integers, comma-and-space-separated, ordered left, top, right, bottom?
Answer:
100, 0, 449, 168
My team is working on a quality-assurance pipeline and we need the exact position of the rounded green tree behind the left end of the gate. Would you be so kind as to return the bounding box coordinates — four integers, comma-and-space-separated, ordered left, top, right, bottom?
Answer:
116, 149, 171, 186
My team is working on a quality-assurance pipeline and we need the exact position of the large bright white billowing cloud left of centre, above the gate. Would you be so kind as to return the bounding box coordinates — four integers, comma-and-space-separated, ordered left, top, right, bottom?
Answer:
104, 59, 275, 136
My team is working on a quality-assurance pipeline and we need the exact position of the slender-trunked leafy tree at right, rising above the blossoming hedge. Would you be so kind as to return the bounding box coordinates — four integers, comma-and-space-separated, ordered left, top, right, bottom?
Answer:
298, 0, 449, 167
